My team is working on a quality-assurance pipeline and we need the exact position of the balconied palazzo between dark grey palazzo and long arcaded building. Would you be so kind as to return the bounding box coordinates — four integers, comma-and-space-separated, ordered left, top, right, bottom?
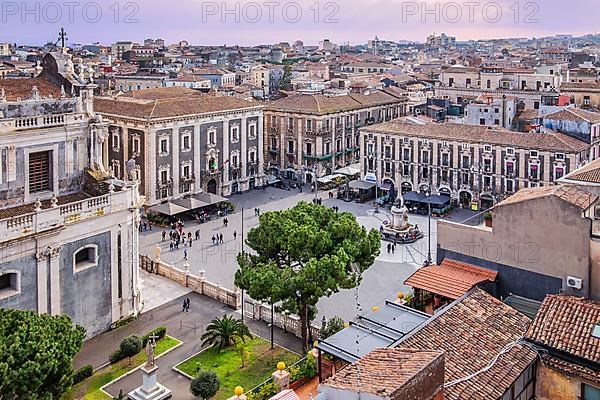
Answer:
264, 90, 407, 182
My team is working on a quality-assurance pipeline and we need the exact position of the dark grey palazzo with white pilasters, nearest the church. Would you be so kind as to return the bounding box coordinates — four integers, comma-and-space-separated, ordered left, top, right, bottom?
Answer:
95, 87, 264, 205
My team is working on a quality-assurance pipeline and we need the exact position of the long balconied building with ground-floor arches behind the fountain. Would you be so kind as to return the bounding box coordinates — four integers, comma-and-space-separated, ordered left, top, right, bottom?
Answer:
360, 118, 590, 209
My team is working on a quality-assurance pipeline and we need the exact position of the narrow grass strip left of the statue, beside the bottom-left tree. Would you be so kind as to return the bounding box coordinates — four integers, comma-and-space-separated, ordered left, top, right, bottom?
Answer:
68, 335, 180, 400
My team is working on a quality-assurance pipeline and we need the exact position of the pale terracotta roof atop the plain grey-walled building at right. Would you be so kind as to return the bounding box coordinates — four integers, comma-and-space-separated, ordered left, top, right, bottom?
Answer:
495, 185, 598, 210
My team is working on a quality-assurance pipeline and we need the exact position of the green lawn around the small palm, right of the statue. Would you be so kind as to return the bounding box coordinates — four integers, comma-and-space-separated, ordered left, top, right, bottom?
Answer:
176, 336, 300, 400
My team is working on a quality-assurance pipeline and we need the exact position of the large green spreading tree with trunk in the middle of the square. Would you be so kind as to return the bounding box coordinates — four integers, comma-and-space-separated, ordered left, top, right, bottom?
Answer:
235, 202, 380, 348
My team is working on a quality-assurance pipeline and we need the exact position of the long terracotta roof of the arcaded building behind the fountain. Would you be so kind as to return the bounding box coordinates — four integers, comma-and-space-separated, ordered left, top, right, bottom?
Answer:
361, 120, 589, 152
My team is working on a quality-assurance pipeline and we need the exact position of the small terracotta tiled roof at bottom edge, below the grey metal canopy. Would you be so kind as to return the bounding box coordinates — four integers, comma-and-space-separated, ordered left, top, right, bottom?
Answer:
325, 347, 444, 398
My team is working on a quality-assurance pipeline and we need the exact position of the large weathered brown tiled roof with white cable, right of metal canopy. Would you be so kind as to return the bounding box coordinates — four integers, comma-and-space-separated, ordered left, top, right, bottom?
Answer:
399, 289, 537, 400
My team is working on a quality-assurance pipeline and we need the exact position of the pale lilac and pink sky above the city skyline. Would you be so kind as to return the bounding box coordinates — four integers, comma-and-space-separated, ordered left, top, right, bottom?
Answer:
0, 0, 600, 45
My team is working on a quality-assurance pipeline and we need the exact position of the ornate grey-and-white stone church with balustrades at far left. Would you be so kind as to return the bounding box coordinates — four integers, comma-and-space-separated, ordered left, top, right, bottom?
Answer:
0, 51, 141, 337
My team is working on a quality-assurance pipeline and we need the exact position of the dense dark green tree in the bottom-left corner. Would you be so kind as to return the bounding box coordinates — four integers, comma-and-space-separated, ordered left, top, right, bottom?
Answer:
0, 309, 85, 400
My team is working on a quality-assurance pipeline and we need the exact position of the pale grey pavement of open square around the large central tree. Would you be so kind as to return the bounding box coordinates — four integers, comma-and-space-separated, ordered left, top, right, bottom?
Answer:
140, 188, 437, 321
